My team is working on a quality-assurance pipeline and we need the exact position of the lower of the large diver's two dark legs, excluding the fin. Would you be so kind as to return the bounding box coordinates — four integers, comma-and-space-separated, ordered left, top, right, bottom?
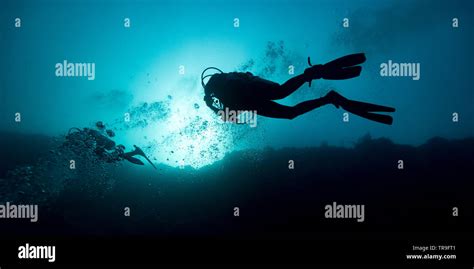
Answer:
256, 97, 331, 120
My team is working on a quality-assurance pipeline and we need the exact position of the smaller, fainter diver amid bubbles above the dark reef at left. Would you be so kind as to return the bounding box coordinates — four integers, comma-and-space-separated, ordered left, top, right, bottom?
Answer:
66, 121, 156, 169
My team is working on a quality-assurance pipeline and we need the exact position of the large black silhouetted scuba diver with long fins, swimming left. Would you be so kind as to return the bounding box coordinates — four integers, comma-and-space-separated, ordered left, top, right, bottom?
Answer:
201, 53, 395, 125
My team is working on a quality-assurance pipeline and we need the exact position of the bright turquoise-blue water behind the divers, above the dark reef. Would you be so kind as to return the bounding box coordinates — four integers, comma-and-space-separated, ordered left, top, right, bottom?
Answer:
0, 0, 474, 168
